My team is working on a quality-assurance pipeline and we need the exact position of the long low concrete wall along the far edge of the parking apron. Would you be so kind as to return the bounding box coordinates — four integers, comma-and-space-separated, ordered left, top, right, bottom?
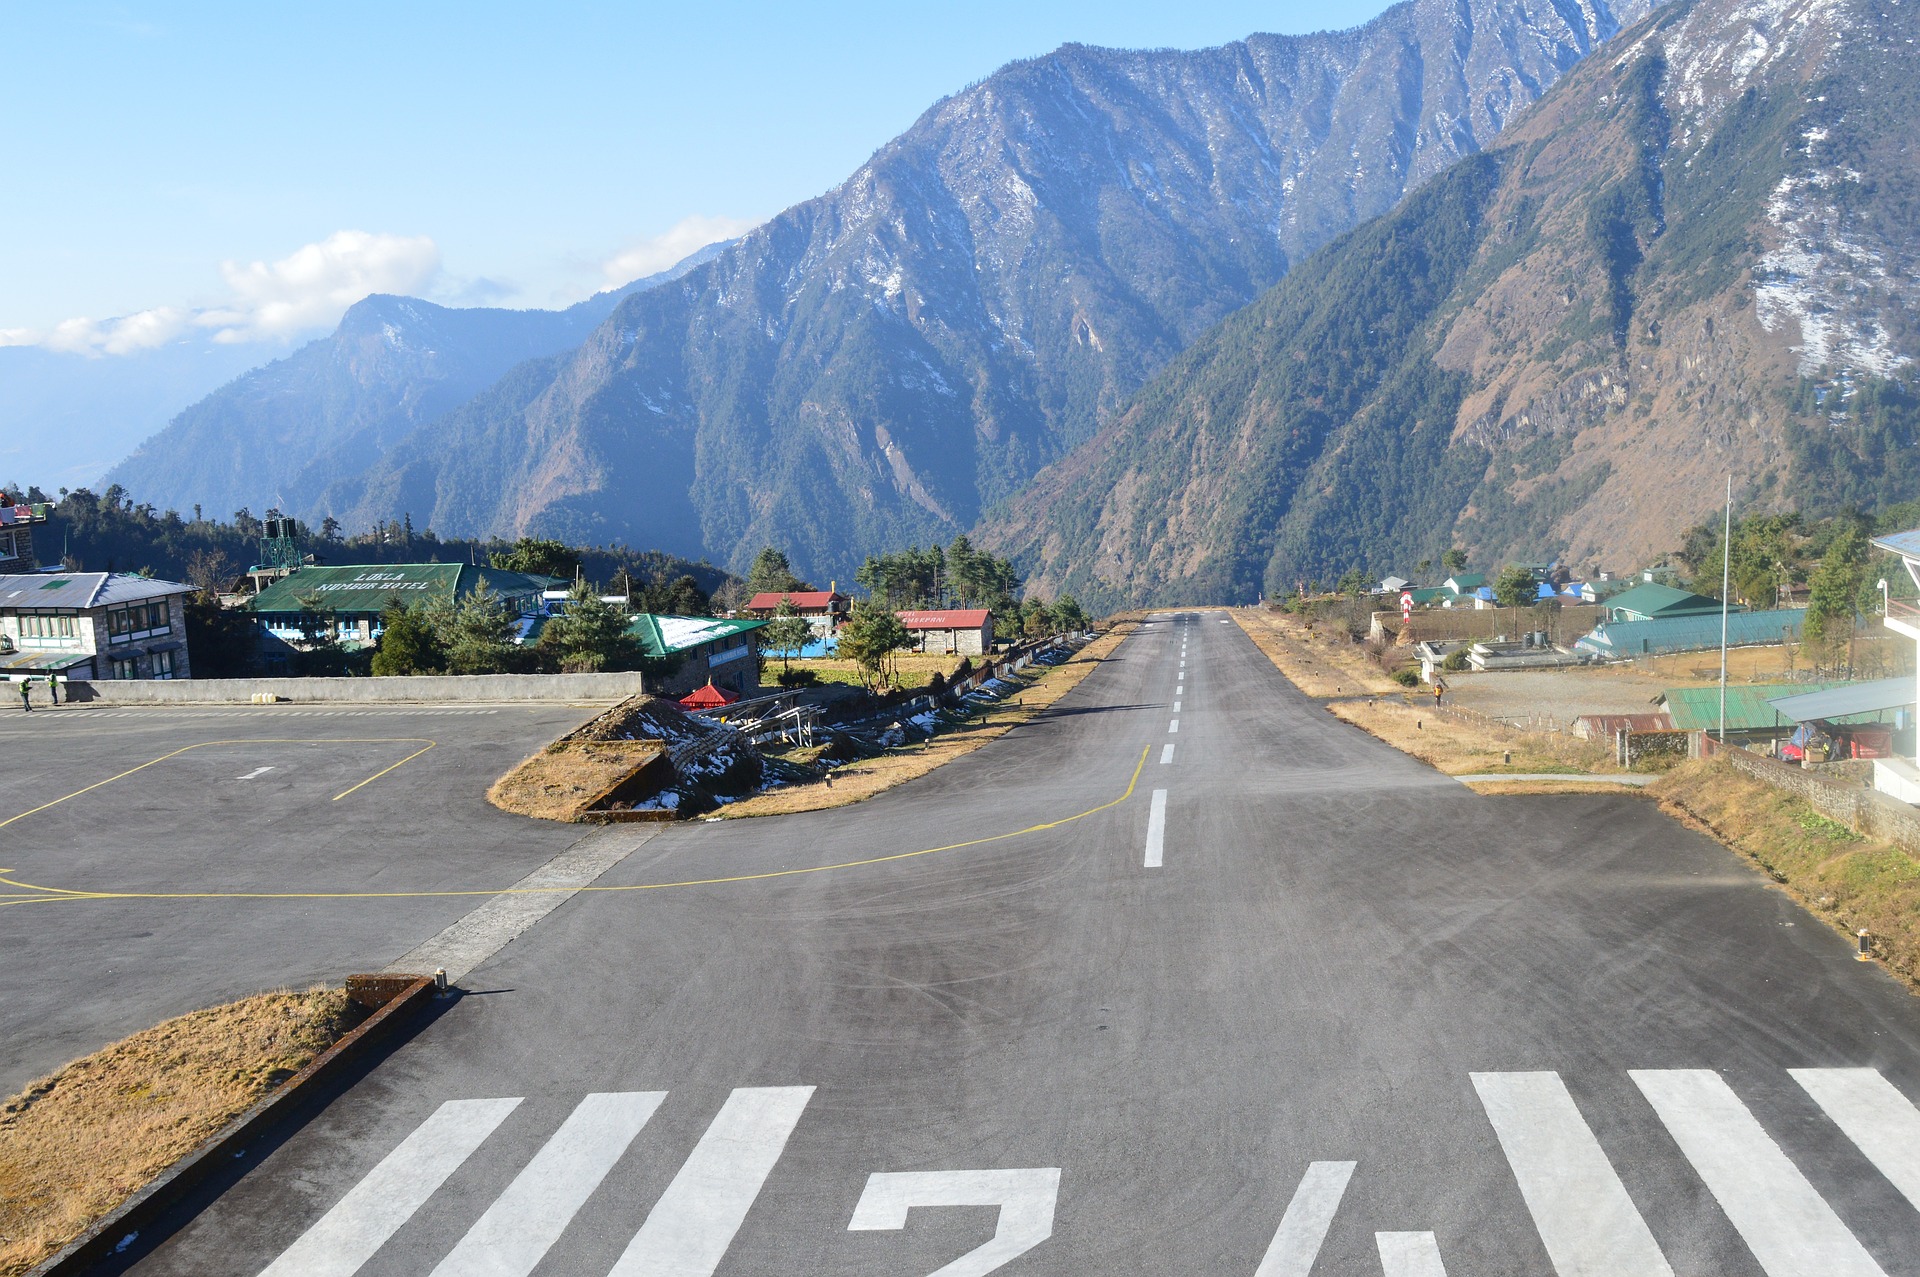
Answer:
63, 674, 643, 705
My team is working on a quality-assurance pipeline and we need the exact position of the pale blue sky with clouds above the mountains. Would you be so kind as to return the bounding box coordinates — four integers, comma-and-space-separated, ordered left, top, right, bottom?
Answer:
0, 0, 1384, 353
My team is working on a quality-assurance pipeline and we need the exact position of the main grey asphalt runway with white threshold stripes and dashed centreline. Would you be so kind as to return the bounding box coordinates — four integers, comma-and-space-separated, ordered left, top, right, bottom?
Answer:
86, 614, 1920, 1277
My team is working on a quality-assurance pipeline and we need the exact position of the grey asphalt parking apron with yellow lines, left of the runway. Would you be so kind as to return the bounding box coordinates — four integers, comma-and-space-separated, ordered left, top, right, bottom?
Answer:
0, 705, 597, 1095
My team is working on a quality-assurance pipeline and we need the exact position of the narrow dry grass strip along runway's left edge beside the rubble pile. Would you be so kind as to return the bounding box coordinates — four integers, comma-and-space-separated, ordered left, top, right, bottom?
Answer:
718, 622, 1135, 820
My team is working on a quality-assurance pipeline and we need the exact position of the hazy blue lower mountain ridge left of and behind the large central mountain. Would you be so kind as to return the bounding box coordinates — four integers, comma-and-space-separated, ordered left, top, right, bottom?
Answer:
106, 244, 720, 522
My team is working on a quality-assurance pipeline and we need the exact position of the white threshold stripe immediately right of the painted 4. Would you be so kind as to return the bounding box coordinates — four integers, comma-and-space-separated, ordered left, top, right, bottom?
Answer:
1471, 1073, 1674, 1277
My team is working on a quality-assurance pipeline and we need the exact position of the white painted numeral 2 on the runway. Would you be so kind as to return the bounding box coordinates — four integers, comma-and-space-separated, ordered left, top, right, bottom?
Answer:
847, 1166, 1060, 1277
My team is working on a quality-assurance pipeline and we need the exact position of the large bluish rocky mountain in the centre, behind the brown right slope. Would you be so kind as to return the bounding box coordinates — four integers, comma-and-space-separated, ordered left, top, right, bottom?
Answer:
299, 0, 1647, 576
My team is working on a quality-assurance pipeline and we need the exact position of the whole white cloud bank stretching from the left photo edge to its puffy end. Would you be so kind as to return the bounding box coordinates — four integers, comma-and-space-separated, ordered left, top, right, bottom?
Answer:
0, 230, 440, 359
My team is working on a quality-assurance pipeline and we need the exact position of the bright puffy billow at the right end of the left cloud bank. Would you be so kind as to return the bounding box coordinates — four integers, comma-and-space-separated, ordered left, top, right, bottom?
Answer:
194, 230, 440, 342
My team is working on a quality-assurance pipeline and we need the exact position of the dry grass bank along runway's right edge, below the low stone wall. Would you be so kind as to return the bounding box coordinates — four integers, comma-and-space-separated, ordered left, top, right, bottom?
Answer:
1647, 759, 1920, 991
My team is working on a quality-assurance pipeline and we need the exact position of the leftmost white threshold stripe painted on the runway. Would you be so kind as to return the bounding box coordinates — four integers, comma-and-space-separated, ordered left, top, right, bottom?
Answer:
259, 1098, 520, 1277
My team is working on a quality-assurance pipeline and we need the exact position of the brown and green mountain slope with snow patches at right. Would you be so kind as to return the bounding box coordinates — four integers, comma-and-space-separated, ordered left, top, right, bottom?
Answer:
981, 0, 1920, 603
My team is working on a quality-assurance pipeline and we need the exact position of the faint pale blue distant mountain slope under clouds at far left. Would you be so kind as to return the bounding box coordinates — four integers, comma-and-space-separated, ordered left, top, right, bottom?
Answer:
0, 338, 273, 492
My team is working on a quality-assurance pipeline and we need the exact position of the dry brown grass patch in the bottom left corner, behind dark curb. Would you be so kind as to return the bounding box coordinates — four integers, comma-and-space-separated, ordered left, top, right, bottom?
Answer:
0, 989, 353, 1277
